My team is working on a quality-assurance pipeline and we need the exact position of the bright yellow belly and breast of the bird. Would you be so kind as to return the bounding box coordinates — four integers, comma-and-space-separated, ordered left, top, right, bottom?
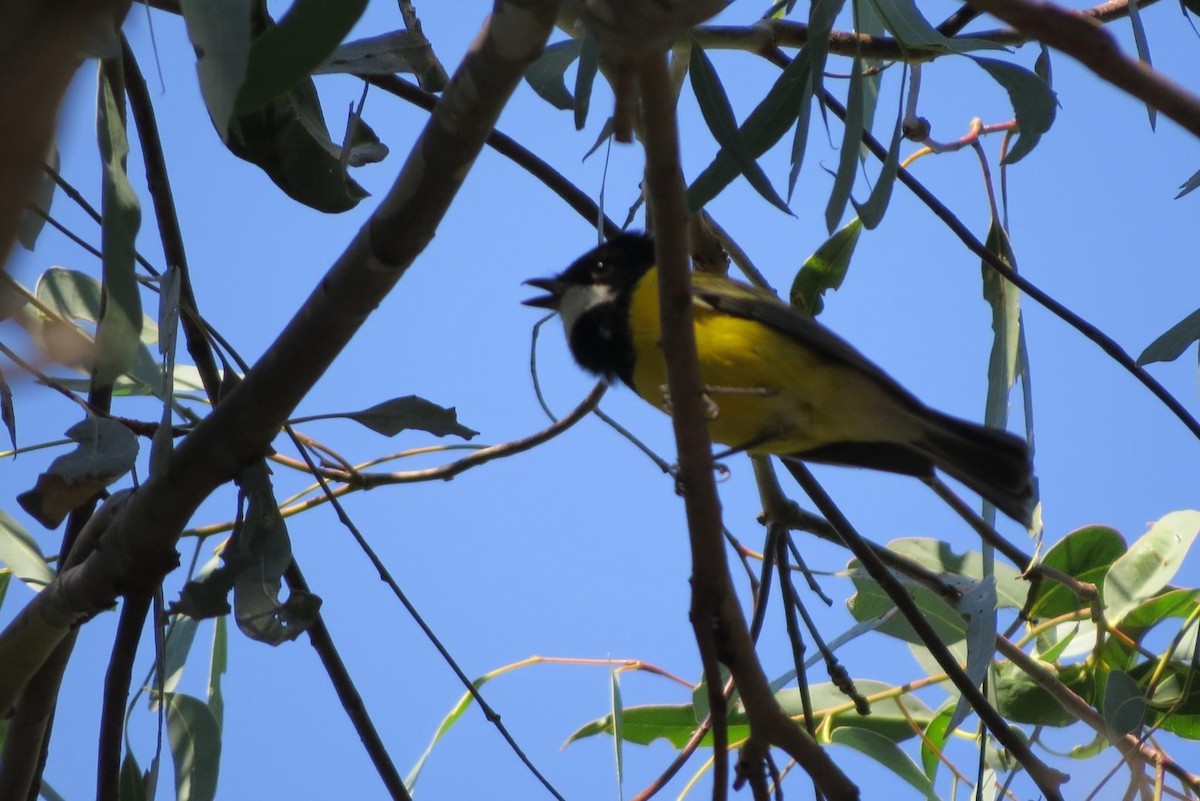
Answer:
630, 271, 908, 453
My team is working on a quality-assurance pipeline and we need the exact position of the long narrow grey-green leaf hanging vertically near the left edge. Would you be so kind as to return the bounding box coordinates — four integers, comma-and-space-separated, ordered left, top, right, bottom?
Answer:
95, 70, 142, 387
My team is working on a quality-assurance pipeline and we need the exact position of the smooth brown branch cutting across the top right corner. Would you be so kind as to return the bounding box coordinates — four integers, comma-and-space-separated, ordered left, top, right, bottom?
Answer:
972, 0, 1200, 137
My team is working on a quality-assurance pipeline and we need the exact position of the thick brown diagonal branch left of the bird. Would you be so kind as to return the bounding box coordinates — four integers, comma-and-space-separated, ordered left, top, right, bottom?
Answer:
0, 0, 558, 729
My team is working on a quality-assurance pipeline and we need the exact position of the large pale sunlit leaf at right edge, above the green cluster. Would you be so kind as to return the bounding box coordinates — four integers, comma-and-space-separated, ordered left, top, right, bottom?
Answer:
1103, 510, 1200, 625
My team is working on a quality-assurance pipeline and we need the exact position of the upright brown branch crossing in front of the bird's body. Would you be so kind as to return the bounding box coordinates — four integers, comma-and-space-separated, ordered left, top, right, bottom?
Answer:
637, 53, 858, 799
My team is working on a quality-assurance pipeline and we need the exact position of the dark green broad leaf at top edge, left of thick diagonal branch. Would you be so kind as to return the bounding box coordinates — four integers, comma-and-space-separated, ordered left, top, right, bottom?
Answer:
236, 0, 367, 114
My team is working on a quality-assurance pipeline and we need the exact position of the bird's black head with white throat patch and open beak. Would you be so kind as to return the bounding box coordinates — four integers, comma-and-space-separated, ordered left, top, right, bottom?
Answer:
524, 234, 654, 384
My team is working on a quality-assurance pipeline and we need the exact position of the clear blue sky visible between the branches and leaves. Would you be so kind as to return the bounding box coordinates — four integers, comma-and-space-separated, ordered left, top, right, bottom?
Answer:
0, 2, 1200, 799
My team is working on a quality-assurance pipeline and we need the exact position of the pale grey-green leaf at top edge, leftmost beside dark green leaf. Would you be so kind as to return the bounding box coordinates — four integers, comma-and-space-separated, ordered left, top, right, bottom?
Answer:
180, 0, 253, 140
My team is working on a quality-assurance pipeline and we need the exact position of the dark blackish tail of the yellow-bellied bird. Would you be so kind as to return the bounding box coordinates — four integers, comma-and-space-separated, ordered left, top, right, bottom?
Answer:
918, 412, 1036, 528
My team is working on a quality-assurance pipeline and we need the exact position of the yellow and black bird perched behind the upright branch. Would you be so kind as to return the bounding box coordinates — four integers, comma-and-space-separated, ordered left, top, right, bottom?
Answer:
523, 231, 1034, 528
